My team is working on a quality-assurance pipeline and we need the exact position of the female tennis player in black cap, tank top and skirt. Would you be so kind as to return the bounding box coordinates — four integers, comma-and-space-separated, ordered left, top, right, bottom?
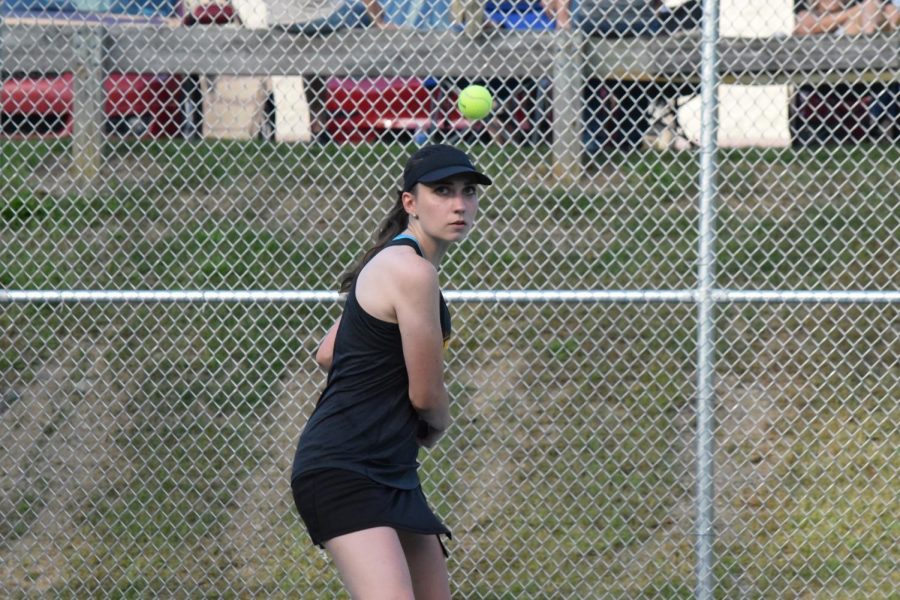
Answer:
291, 144, 491, 600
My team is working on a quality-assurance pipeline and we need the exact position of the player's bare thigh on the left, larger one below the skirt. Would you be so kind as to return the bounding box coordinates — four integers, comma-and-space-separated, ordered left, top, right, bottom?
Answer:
323, 527, 414, 600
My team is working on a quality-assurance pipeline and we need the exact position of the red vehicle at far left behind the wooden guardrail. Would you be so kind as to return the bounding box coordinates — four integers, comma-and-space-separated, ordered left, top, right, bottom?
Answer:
0, 0, 231, 138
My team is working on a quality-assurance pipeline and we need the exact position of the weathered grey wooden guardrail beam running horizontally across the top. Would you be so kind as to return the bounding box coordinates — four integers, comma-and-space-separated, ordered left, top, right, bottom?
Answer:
0, 25, 900, 80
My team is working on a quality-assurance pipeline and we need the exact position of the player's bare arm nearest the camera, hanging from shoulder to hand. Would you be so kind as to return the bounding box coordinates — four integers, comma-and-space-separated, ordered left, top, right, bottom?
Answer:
394, 260, 450, 438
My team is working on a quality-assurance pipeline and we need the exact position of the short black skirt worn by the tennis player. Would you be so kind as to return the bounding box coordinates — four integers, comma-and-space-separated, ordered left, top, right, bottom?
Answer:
291, 469, 451, 554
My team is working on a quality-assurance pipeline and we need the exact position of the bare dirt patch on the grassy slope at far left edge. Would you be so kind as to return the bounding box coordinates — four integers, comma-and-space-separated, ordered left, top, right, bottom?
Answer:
0, 337, 130, 596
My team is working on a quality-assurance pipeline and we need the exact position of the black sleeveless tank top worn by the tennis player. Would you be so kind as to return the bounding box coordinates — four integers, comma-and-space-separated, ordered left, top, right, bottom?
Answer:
291, 237, 450, 489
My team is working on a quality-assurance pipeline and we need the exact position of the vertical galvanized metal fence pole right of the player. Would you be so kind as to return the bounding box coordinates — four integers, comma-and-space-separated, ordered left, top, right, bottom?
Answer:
695, 0, 719, 600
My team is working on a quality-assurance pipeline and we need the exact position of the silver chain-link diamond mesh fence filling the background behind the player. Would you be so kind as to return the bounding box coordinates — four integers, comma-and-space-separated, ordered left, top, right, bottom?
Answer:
0, 0, 900, 599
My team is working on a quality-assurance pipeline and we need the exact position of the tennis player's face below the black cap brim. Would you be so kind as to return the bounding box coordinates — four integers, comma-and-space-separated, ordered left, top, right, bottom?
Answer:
416, 175, 478, 242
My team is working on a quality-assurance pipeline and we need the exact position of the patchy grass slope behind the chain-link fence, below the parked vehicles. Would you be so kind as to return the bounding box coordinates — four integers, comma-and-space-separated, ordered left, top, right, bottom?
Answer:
0, 142, 900, 598
